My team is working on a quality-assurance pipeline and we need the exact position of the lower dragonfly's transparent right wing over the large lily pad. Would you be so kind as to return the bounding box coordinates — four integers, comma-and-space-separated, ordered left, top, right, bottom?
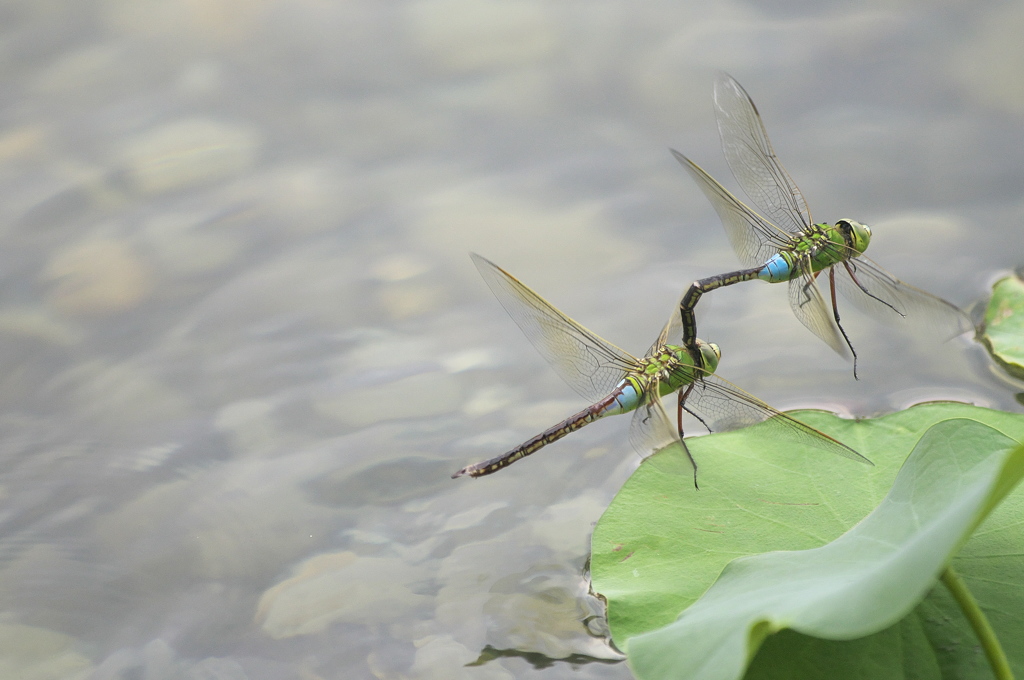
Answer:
686, 375, 871, 465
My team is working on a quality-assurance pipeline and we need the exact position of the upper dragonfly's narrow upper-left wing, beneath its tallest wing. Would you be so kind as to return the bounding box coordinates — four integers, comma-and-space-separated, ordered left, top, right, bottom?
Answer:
670, 150, 790, 267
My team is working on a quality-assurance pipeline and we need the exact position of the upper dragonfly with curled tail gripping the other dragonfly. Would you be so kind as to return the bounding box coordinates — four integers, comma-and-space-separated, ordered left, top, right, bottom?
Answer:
672, 74, 974, 378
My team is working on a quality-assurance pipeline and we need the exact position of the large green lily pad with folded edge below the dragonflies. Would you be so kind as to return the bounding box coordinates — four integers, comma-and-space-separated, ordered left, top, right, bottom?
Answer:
592, 403, 1024, 678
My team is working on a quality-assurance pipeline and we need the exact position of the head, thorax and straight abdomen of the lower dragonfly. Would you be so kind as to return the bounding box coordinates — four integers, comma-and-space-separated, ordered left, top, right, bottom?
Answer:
452, 340, 721, 477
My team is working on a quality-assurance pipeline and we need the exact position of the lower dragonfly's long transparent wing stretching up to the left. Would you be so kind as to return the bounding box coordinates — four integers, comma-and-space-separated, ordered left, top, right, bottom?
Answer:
470, 253, 637, 401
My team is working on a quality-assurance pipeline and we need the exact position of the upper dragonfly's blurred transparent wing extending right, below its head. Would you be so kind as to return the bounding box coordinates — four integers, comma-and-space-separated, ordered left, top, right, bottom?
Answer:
833, 256, 974, 340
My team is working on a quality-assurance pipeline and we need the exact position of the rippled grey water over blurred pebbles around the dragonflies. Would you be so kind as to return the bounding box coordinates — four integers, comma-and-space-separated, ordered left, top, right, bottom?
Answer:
0, 0, 1024, 680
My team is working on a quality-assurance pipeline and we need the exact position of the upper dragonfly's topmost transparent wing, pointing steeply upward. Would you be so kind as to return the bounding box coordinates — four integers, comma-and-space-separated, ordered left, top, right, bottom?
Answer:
715, 73, 811, 233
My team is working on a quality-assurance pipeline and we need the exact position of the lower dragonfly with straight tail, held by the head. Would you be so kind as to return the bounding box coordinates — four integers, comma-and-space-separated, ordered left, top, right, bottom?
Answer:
452, 253, 870, 486
